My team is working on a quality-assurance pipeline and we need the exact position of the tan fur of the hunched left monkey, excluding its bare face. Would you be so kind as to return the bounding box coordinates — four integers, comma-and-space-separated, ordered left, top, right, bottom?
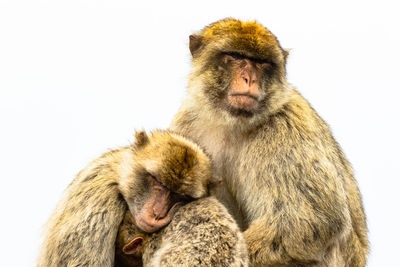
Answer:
38, 131, 212, 267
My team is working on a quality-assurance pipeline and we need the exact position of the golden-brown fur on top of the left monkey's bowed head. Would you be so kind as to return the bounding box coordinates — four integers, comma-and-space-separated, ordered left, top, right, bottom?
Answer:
120, 131, 212, 203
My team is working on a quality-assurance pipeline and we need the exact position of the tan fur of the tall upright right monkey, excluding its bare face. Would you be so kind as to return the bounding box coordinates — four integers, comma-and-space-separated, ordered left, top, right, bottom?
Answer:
171, 19, 368, 266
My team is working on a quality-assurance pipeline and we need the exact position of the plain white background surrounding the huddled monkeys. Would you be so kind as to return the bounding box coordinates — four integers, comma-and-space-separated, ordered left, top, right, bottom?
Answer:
0, 0, 400, 266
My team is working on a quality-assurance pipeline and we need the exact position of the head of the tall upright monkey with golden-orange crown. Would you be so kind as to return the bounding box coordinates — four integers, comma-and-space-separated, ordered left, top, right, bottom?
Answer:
189, 18, 289, 125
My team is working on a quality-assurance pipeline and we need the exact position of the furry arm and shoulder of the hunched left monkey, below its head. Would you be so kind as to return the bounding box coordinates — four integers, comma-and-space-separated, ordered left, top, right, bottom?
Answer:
38, 151, 126, 267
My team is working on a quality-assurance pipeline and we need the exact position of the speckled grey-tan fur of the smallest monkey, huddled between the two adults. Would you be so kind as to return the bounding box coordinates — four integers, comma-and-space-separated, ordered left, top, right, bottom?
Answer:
117, 197, 249, 267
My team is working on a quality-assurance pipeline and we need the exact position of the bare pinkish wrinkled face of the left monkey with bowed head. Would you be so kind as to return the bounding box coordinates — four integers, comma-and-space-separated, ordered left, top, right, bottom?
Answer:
129, 174, 192, 233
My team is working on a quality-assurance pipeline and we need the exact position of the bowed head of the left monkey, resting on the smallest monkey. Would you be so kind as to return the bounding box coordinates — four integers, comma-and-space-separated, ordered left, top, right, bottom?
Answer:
121, 131, 212, 233
